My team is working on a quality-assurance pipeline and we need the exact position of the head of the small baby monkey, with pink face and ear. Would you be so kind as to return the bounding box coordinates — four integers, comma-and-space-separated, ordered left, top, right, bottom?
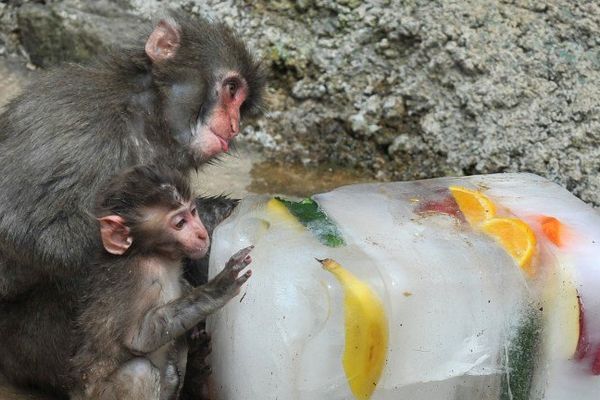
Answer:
94, 166, 210, 260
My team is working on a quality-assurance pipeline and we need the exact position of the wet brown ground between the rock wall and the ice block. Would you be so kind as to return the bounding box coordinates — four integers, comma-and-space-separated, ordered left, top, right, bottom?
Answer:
0, 56, 376, 198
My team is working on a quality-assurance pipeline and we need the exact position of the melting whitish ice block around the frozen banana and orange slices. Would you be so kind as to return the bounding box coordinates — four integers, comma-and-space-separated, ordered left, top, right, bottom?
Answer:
208, 174, 600, 400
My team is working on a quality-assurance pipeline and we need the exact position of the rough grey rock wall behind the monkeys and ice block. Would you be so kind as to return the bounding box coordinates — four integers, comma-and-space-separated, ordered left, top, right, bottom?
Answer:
0, 0, 600, 206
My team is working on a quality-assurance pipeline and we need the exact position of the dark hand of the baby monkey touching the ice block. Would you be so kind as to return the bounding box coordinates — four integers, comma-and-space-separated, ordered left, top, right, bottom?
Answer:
206, 246, 254, 299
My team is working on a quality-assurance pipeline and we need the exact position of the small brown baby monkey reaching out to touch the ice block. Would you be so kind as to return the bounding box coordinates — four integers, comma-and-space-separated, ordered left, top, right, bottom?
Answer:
72, 166, 252, 400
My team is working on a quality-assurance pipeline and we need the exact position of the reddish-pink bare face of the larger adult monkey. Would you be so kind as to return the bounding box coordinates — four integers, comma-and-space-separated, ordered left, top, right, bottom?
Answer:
192, 72, 248, 158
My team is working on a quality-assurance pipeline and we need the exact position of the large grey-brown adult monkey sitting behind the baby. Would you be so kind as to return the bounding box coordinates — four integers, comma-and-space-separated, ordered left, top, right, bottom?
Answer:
0, 15, 264, 395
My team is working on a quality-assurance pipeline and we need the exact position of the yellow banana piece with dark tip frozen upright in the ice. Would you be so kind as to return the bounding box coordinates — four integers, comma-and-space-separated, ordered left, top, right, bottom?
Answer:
319, 258, 388, 400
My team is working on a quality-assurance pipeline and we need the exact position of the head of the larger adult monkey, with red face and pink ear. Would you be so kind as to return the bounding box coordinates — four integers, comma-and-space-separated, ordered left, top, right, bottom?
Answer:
146, 19, 265, 164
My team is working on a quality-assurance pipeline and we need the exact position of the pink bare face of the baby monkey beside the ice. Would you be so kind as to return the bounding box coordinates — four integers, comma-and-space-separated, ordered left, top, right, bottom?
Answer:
167, 202, 210, 260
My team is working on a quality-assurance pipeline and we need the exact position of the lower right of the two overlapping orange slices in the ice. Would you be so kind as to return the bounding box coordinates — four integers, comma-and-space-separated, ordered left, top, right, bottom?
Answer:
480, 218, 537, 275
